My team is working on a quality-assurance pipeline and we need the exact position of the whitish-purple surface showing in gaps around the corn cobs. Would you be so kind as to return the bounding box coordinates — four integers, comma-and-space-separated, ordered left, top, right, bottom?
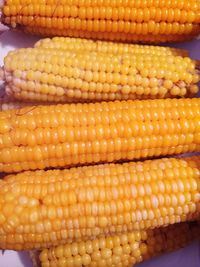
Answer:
0, 31, 200, 267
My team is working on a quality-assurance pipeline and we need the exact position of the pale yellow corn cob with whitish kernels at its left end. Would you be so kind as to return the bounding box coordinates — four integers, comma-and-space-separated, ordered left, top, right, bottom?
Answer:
2, 44, 200, 102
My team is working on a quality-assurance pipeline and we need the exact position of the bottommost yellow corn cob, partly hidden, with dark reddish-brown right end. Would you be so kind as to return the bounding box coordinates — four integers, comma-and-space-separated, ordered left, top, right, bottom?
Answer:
39, 223, 200, 267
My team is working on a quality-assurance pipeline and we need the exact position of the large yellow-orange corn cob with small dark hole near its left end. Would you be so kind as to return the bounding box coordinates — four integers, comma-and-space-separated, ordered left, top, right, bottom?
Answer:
0, 157, 200, 250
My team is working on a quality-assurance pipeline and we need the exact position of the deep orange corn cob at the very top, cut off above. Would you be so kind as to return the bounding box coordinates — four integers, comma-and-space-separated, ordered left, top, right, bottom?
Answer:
3, 0, 200, 42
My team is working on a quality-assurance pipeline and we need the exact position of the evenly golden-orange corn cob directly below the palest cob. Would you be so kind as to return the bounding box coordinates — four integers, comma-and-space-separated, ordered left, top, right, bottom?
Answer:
0, 98, 200, 172
